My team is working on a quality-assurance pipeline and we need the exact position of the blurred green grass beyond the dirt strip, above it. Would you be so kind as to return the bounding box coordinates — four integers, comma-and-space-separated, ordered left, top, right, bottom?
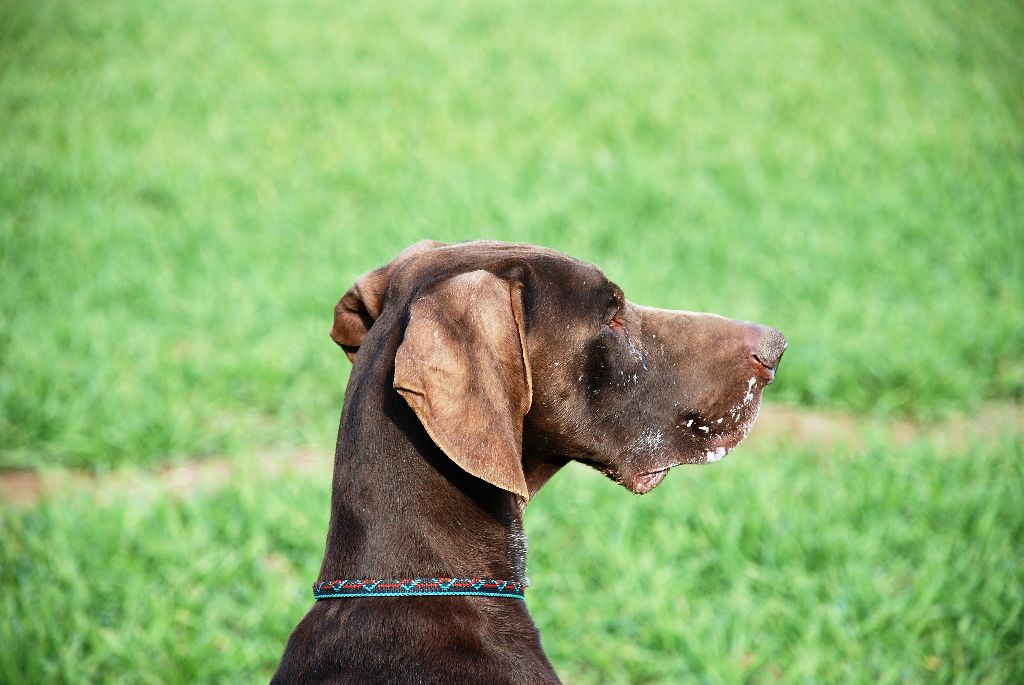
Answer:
0, 0, 1024, 468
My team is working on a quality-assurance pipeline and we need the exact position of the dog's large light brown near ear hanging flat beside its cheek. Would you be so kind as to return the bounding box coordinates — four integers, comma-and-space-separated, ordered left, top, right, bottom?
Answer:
394, 270, 532, 500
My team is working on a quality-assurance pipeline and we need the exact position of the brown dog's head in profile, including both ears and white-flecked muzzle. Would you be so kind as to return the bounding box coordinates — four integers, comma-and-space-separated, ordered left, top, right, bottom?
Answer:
332, 242, 786, 500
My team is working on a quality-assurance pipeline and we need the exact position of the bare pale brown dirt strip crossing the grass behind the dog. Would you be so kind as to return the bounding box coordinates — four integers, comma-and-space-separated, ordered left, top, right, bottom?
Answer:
0, 403, 1024, 508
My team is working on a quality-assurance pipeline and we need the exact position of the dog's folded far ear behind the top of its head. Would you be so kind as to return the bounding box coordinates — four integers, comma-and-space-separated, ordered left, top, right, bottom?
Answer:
331, 241, 445, 362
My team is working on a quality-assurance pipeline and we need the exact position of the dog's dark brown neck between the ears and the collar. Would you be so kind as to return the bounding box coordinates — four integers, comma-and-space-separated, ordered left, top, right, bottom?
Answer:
319, 320, 526, 581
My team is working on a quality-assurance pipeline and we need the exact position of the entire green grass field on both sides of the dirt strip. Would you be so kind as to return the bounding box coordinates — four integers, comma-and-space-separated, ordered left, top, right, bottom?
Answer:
0, 0, 1024, 683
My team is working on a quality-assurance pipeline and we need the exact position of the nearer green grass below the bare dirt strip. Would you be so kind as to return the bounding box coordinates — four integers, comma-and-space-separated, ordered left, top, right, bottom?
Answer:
0, 439, 1024, 685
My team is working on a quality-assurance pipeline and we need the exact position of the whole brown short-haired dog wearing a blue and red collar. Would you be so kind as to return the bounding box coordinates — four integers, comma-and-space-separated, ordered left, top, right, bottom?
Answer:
273, 242, 786, 684
